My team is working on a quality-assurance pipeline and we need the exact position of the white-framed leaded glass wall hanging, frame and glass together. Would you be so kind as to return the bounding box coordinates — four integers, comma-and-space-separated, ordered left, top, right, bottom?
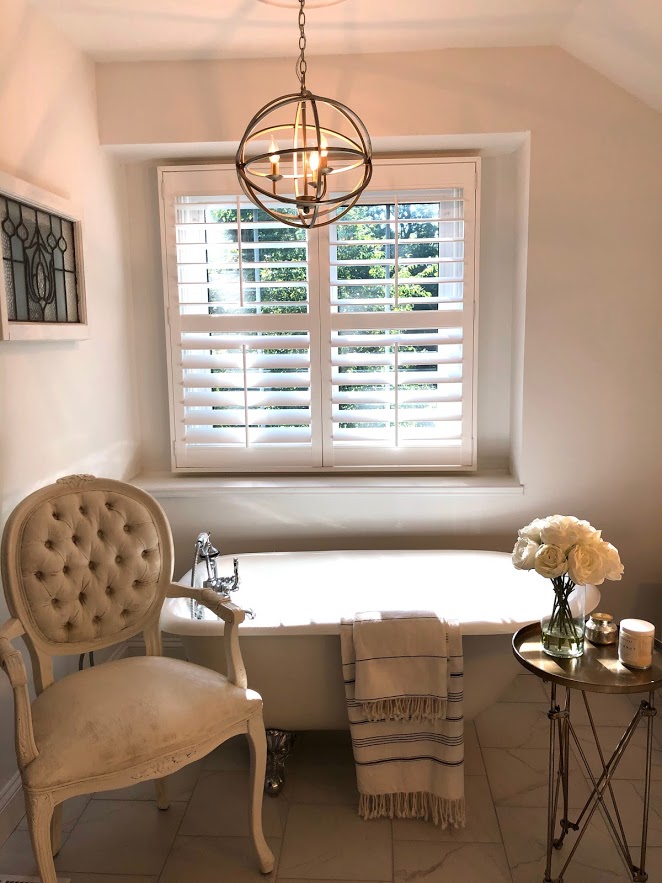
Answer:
0, 172, 89, 341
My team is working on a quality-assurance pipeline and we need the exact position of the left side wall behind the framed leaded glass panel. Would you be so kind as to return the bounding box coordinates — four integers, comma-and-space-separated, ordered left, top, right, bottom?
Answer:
0, 0, 138, 820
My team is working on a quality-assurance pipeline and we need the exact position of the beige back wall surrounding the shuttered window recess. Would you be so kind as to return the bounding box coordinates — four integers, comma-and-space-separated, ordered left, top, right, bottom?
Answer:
97, 48, 662, 628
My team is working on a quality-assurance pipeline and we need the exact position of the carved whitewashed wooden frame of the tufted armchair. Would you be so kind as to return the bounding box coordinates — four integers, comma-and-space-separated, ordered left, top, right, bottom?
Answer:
0, 476, 274, 883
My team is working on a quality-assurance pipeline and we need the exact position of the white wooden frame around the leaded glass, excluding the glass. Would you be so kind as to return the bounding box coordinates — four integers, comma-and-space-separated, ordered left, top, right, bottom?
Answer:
0, 171, 89, 341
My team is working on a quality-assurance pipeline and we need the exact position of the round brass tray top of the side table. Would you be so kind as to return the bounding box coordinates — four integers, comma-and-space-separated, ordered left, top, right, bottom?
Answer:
513, 623, 662, 693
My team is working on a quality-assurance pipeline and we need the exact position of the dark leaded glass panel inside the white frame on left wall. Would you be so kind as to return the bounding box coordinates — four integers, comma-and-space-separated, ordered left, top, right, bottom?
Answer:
0, 193, 80, 323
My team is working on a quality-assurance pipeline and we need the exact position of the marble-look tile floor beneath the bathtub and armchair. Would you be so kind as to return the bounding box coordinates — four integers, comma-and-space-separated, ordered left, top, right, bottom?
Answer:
0, 674, 662, 883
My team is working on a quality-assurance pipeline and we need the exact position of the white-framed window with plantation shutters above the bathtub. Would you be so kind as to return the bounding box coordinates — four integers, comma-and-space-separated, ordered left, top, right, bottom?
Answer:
159, 158, 479, 472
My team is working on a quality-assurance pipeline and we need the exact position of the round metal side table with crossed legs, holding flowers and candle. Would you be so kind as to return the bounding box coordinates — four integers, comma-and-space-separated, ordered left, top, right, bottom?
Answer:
513, 624, 662, 883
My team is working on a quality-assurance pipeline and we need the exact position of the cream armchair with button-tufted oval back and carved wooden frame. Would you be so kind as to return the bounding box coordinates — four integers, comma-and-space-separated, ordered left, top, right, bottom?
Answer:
0, 475, 274, 883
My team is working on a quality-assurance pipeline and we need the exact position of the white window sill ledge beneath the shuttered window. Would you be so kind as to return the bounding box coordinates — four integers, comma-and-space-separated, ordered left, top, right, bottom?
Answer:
131, 472, 524, 499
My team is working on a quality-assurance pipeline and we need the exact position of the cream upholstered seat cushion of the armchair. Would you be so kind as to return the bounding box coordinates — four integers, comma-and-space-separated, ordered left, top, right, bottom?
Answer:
23, 656, 262, 789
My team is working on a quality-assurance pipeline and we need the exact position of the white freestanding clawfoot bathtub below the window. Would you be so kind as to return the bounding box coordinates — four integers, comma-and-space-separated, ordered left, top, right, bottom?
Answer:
161, 551, 600, 731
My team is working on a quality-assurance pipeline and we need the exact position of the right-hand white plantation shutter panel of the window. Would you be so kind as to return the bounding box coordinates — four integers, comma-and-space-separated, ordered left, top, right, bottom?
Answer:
325, 179, 475, 467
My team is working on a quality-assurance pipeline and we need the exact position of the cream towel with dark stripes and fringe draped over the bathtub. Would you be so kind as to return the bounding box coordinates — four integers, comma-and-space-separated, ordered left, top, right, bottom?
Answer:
340, 611, 465, 828
